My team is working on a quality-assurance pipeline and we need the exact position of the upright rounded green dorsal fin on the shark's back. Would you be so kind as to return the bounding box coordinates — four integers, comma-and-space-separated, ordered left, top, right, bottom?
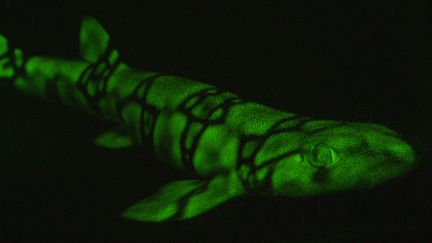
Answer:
80, 16, 109, 63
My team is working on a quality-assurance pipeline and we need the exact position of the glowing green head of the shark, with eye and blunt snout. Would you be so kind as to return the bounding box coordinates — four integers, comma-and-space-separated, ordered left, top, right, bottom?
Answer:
269, 120, 416, 196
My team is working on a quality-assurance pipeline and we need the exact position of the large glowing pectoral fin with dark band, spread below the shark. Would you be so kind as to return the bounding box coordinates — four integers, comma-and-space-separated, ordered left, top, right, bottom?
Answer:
122, 174, 243, 222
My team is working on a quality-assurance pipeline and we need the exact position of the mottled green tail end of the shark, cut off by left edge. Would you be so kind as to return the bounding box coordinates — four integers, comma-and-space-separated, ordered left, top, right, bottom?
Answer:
0, 34, 25, 79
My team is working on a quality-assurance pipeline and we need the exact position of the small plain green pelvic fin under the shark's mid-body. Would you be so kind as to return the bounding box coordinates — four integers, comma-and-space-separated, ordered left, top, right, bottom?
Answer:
94, 127, 134, 149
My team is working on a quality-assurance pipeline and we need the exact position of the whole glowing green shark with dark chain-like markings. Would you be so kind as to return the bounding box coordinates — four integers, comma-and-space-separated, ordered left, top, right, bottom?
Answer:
0, 17, 416, 222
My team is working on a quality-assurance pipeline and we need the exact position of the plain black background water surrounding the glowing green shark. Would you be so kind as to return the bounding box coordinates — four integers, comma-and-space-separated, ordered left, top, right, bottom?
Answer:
0, 0, 432, 242
